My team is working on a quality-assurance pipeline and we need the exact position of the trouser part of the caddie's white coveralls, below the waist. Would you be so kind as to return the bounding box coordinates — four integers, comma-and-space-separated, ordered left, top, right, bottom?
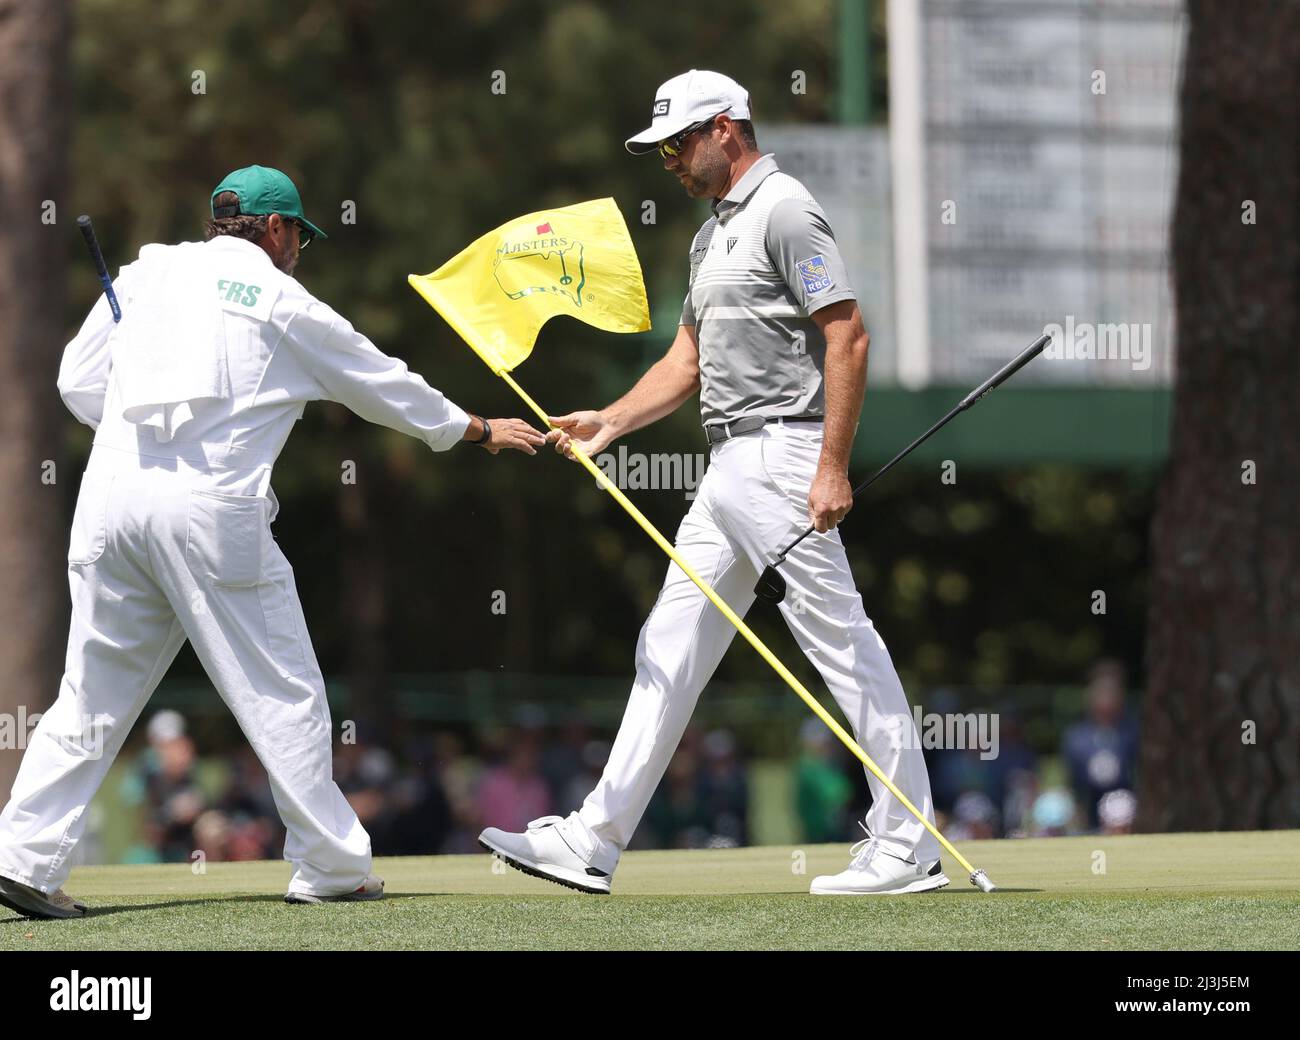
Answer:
0, 447, 371, 894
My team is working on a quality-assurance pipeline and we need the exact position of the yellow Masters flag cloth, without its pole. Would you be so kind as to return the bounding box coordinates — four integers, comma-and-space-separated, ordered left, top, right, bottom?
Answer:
407, 199, 650, 376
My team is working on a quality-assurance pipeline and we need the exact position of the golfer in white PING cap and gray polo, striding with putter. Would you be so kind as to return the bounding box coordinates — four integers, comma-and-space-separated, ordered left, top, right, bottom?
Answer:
480, 70, 948, 896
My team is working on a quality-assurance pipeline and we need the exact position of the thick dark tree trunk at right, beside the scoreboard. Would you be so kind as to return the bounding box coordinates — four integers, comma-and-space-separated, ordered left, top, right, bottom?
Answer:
1139, 0, 1300, 831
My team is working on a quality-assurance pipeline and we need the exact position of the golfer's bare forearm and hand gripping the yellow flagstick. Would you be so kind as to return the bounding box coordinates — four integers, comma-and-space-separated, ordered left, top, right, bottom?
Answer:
546, 325, 699, 458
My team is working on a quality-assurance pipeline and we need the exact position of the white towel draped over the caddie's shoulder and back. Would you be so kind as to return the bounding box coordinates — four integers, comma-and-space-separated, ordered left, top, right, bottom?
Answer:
112, 242, 231, 442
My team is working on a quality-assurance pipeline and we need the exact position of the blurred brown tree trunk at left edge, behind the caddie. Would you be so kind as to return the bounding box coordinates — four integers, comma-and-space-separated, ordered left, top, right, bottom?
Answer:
0, 0, 77, 801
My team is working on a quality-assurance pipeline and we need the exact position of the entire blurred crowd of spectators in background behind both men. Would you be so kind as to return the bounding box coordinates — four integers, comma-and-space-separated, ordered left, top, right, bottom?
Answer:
121, 660, 1138, 862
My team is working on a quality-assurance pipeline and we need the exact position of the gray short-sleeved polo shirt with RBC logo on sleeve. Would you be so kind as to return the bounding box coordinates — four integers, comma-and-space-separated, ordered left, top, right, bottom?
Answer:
681, 155, 857, 425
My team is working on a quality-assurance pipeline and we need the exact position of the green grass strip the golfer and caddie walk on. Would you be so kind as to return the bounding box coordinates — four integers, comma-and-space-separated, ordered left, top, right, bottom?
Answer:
0, 831, 1300, 950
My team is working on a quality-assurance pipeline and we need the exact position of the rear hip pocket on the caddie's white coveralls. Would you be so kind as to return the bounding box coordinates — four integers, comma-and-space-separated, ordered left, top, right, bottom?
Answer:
185, 491, 269, 589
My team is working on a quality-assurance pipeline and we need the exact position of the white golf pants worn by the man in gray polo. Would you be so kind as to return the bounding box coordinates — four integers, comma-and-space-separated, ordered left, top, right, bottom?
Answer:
579, 423, 939, 870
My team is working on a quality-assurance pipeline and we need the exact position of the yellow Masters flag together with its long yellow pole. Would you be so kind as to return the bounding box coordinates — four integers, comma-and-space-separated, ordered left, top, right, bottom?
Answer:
407, 199, 995, 892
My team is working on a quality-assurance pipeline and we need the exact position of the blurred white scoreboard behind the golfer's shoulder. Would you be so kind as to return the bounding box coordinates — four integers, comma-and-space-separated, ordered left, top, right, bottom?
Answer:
759, 0, 1186, 386
